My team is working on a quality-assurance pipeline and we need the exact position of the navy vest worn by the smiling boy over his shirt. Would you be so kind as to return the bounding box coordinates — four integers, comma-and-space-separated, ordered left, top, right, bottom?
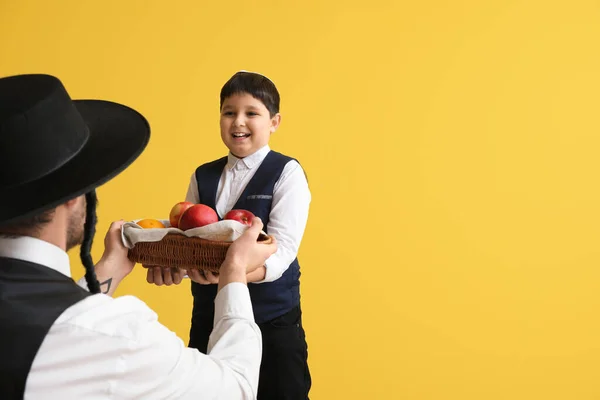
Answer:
192, 151, 300, 324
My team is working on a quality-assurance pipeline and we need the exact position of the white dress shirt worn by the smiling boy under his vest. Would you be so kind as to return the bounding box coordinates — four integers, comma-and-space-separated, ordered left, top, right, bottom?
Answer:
186, 145, 311, 283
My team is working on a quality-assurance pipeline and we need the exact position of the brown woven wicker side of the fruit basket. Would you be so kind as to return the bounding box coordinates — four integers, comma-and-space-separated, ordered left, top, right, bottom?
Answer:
128, 233, 273, 272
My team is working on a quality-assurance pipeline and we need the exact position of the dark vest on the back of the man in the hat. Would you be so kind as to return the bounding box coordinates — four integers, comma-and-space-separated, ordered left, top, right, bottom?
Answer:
0, 257, 90, 400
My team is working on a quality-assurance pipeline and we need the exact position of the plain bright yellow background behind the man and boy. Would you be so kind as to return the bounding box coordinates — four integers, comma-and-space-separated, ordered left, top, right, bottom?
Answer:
0, 0, 600, 400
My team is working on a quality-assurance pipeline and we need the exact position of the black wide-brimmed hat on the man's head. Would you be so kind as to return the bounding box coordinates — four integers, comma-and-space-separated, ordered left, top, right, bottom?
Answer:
0, 74, 150, 226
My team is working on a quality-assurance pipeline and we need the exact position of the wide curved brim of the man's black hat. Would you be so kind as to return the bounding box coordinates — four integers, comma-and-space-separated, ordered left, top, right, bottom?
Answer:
0, 100, 150, 224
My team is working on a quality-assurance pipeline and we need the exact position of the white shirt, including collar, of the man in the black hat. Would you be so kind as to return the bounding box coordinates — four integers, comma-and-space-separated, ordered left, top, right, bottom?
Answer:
0, 237, 262, 400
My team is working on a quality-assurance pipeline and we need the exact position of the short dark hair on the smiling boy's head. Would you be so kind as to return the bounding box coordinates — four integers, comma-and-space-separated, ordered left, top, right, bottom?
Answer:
219, 71, 279, 117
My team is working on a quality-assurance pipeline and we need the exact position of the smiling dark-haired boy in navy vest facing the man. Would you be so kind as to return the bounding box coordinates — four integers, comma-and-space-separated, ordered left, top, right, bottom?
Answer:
148, 71, 311, 400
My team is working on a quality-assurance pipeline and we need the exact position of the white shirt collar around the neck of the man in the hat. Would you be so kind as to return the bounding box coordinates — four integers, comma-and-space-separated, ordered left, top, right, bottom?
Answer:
0, 236, 71, 278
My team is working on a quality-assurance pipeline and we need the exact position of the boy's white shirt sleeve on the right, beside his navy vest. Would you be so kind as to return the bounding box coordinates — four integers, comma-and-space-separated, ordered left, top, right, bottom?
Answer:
255, 160, 311, 284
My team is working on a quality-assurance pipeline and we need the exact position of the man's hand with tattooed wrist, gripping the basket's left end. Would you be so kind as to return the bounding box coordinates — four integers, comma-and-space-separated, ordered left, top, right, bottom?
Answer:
96, 220, 135, 296
